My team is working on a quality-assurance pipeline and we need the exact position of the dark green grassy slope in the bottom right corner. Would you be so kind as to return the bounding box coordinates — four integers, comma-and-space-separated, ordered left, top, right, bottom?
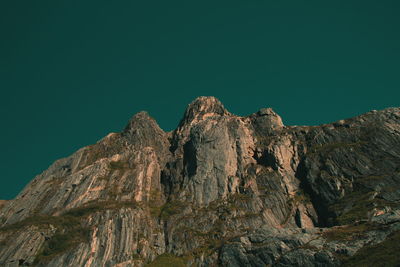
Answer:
343, 231, 400, 266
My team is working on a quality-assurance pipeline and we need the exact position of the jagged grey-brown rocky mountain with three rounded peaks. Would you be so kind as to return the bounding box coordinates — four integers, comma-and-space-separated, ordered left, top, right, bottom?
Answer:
0, 97, 400, 267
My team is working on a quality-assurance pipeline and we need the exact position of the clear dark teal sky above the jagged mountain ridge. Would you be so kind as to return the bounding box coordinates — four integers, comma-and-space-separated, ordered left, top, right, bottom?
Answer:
0, 0, 400, 199
